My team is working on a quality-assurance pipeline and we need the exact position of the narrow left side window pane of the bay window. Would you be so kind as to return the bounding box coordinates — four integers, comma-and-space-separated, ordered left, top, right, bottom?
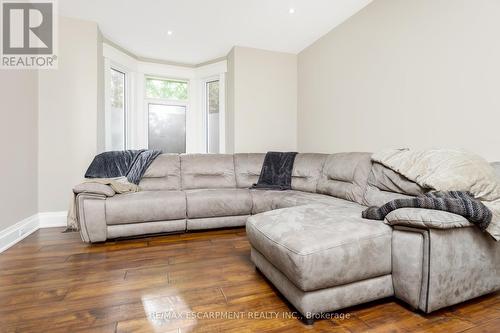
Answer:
107, 69, 125, 150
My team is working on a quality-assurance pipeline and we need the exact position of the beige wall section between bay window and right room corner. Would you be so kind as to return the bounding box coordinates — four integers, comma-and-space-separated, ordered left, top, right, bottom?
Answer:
226, 46, 297, 152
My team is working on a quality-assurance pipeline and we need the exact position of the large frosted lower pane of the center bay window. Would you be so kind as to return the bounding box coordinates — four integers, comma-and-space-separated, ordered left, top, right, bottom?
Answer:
148, 104, 186, 153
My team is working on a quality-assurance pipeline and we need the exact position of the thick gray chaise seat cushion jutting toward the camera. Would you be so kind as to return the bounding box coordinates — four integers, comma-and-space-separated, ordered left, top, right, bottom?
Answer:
246, 204, 392, 291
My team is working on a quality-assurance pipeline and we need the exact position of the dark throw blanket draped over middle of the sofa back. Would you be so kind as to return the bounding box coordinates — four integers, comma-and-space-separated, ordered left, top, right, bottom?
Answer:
252, 151, 297, 190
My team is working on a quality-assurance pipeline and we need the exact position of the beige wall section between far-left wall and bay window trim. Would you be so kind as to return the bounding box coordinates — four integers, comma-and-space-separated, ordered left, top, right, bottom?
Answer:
38, 17, 103, 212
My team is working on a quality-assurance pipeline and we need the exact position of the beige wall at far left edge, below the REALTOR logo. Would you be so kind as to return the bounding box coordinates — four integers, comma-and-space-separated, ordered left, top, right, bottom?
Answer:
0, 70, 38, 231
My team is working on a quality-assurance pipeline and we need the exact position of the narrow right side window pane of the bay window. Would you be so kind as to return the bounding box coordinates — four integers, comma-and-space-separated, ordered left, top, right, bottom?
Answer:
207, 81, 219, 154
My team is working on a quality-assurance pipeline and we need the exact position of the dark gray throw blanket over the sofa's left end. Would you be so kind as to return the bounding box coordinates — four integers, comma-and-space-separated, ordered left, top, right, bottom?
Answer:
85, 149, 161, 185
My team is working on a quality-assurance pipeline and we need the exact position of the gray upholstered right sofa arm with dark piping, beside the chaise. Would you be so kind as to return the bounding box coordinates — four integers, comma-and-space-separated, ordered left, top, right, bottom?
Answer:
392, 226, 500, 313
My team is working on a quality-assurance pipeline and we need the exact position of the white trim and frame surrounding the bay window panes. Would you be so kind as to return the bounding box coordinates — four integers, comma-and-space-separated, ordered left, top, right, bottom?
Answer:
102, 41, 227, 153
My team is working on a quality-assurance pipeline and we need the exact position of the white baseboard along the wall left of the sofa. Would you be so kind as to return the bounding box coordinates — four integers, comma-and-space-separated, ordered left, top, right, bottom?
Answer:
0, 212, 67, 253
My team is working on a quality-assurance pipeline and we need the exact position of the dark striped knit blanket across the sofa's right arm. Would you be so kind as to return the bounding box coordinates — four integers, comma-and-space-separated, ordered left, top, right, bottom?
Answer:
362, 191, 492, 231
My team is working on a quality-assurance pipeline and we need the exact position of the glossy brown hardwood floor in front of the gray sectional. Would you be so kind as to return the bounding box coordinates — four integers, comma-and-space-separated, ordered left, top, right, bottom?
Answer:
0, 228, 500, 333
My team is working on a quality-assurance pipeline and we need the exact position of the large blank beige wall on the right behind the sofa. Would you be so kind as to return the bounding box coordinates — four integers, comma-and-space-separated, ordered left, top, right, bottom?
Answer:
298, 0, 500, 160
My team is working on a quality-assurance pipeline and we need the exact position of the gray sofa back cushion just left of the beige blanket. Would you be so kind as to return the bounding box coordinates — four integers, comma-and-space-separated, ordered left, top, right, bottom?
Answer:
317, 153, 372, 204
